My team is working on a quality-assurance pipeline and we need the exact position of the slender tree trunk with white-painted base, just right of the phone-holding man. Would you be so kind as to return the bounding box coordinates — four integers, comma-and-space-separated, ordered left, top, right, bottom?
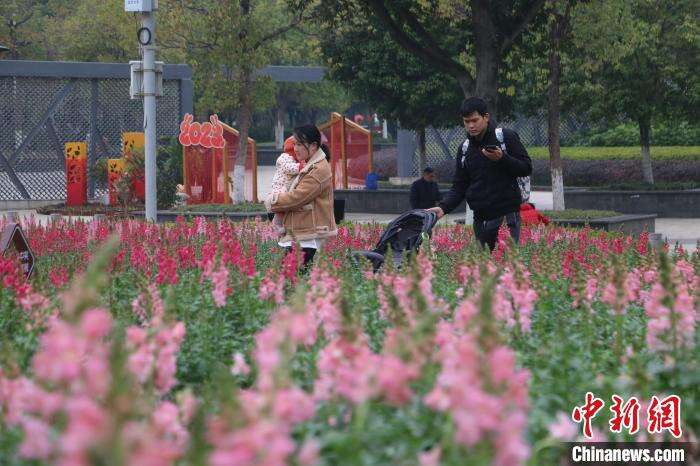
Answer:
547, 9, 564, 210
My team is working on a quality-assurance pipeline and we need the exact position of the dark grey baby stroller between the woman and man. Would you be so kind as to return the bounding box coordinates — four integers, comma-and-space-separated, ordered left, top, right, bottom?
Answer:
352, 209, 438, 272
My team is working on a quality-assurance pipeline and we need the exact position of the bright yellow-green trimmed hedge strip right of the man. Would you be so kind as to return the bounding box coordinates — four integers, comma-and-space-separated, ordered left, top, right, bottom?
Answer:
527, 146, 700, 160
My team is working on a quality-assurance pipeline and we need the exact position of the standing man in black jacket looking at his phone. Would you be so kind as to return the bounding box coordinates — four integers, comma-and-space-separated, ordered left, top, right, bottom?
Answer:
428, 97, 532, 250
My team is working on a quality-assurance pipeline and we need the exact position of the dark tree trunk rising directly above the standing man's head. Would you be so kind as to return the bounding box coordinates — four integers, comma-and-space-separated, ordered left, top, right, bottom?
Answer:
472, 0, 501, 121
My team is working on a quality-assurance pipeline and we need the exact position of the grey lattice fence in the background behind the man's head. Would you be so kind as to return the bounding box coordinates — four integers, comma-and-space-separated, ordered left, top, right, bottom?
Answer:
400, 113, 588, 176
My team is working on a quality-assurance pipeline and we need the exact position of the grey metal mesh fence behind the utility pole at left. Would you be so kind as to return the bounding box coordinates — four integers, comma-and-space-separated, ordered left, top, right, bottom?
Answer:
0, 60, 193, 200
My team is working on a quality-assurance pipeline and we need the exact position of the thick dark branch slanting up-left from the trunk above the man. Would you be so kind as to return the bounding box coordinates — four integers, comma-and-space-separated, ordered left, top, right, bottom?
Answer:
362, 0, 474, 87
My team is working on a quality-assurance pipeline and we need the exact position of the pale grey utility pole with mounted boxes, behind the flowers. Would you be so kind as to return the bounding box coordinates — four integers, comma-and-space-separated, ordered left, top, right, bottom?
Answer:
124, 0, 163, 222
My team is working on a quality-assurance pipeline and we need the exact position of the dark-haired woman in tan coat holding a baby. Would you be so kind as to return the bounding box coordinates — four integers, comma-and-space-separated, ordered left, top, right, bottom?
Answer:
265, 125, 337, 269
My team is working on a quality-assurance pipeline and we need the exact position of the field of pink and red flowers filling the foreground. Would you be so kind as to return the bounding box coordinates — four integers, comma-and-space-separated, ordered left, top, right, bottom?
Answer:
0, 218, 700, 466
